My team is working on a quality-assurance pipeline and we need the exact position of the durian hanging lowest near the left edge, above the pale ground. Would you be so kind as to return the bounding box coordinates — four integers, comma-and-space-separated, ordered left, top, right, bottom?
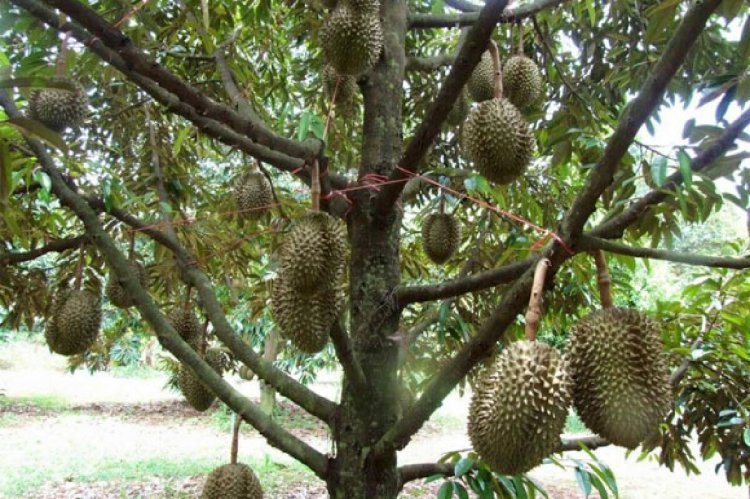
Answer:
45, 290, 102, 355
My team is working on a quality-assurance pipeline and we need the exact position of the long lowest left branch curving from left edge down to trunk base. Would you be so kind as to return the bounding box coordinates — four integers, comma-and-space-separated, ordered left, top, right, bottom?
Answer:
0, 91, 328, 479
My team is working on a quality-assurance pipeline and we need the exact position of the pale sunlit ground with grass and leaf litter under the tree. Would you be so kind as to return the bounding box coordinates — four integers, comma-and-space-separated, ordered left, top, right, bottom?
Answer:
0, 343, 747, 499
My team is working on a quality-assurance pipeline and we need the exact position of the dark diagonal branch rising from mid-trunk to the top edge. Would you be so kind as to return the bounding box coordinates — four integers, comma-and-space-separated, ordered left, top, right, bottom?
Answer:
377, 0, 508, 214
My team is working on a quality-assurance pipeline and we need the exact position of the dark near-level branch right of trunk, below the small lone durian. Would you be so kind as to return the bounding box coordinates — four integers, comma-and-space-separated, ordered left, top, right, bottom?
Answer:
396, 258, 536, 307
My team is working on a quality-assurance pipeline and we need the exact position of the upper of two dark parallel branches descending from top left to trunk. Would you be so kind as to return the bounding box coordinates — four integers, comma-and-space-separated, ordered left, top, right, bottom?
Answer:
45, 0, 322, 159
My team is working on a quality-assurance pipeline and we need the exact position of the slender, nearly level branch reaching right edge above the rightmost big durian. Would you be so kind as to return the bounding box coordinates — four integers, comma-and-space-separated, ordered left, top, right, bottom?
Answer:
576, 235, 750, 269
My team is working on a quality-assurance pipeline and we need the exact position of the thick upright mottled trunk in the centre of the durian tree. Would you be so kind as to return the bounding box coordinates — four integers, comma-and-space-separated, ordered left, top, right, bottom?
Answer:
328, 0, 406, 499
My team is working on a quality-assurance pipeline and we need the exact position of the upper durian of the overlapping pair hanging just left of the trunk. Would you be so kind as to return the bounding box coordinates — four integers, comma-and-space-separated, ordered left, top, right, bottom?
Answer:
279, 211, 346, 295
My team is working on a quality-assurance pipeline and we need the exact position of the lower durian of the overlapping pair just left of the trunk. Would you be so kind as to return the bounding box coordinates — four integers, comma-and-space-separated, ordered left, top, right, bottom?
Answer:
271, 274, 343, 353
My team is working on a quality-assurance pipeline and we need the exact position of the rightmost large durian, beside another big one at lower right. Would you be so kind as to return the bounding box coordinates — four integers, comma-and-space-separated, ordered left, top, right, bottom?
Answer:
566, 307, 671, 449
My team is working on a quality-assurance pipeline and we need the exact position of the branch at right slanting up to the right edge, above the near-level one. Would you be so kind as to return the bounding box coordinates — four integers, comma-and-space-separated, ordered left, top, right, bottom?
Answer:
589, 109, 750, 239
